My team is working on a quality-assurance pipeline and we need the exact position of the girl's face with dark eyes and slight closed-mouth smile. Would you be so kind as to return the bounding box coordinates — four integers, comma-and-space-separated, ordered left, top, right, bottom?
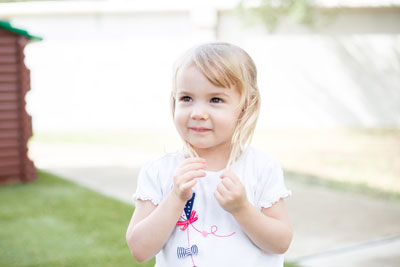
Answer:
174, 65, 241, 156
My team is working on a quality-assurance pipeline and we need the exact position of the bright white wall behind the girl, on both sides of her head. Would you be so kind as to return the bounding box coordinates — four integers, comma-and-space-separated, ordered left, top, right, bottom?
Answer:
0, 1, 400, 131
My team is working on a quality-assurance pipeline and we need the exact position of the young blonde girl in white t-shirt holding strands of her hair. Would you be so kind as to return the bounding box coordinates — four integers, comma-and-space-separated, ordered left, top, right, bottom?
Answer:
126, 43, 293, 267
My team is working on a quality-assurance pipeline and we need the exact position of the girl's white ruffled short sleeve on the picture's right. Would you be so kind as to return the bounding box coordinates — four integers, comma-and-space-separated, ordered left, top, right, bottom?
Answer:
256, 160, 292, 209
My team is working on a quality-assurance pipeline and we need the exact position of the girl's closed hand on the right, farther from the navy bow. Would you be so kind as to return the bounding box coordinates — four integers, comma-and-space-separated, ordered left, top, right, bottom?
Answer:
214, 170, 247, 214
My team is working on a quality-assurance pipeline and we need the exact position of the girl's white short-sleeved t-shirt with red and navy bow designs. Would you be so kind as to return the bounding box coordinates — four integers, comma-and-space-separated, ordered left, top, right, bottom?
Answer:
133, 147, 291, 267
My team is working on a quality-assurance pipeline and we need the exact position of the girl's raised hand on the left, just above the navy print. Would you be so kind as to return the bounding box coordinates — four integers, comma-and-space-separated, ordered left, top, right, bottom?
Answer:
173, 158, 206, 202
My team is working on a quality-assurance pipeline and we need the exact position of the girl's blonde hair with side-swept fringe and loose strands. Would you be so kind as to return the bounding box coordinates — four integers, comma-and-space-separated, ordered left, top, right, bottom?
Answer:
171, 42, 261, 169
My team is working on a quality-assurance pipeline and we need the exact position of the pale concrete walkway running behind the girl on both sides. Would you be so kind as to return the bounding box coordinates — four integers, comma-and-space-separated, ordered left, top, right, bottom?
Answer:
29, 143, 400, 267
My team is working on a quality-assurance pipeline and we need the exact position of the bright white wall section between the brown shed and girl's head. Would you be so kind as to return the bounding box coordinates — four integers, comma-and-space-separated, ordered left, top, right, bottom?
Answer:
18, 13, 195, 131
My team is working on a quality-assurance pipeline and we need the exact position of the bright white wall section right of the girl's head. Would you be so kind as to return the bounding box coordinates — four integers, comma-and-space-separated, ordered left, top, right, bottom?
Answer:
218, 8, 400, 127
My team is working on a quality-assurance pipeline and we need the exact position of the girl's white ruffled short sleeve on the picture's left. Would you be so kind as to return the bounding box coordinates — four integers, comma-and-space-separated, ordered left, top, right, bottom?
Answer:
132, 162, 162, 205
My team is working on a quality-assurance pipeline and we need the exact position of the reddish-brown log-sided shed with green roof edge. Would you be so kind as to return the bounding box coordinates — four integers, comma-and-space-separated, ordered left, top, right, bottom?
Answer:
0, 20, 41, 184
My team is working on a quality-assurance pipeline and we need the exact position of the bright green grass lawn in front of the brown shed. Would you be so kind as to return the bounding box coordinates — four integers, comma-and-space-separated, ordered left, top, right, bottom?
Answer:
0, 171, 297, 267
